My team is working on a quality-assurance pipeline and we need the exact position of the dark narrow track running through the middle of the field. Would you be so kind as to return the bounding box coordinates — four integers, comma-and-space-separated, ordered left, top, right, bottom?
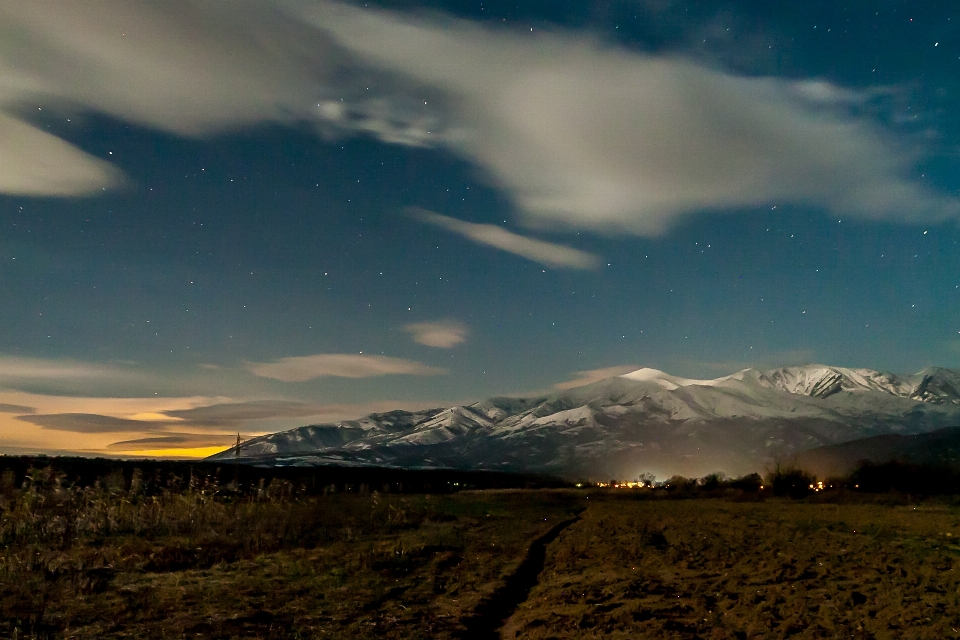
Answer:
460, 509, 584, 640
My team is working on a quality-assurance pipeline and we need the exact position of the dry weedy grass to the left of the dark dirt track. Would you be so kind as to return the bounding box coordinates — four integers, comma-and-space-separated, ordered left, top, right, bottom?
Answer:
0, 469, 571, 638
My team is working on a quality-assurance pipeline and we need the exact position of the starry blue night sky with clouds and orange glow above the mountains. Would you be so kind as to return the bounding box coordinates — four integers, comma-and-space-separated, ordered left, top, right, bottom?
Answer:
0, 0, 960, 455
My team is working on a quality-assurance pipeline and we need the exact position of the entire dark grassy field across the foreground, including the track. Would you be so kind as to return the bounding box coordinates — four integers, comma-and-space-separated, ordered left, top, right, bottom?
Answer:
0, 468, 960, 639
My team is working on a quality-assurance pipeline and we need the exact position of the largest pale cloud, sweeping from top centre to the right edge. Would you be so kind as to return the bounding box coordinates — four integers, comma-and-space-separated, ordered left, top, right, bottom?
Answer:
304, 3, 960, 235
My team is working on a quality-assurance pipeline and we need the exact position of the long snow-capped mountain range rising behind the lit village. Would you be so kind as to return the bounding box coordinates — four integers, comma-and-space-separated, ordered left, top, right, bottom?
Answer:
213, 365, 960, 478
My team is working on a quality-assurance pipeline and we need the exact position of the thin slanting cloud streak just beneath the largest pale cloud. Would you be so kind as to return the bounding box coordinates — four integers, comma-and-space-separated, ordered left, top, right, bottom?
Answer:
410, 208, 600, 269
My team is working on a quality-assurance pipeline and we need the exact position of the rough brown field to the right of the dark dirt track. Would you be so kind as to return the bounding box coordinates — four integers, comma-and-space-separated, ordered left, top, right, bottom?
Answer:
504, 495, 960, 639
